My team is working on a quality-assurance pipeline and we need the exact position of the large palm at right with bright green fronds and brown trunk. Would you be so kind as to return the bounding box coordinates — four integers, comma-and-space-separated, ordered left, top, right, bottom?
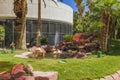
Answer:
76, 0, 120, 52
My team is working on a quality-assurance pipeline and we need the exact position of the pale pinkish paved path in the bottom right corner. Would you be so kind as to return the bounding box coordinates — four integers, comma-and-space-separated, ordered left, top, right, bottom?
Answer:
95, 71, 120, 80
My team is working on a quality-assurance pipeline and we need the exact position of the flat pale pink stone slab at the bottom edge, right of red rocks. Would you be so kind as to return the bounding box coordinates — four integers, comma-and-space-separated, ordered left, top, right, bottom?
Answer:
33, 71, 58, 80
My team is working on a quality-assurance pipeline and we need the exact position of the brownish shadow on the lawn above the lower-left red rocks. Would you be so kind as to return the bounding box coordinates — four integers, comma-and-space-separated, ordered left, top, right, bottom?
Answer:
0, 61, 14, 72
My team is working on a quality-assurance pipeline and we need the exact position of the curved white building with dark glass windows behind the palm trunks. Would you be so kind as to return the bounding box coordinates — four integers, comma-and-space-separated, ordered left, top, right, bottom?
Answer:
0, 0, 73, 45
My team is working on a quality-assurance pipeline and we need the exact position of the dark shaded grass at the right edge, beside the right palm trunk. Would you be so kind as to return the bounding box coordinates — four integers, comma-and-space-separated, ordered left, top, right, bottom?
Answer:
108, 40, 120, 56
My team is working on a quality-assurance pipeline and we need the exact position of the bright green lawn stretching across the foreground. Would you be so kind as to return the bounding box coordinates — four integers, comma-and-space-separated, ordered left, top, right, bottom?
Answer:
0, 41, 120, 80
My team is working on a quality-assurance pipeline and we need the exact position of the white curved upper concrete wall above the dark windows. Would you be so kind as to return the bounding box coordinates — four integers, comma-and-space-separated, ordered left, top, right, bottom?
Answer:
0, 0, 73, 24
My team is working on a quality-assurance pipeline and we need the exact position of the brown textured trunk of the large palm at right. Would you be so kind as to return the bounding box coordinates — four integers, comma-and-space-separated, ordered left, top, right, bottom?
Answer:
100, 11, 110, 52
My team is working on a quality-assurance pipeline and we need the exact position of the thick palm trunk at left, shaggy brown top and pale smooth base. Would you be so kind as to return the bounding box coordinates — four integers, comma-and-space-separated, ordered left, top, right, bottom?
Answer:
14, 0, 27, 49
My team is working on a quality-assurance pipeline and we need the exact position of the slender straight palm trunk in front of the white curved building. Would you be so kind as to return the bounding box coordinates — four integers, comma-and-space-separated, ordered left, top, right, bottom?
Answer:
36, 0, 41, 47
